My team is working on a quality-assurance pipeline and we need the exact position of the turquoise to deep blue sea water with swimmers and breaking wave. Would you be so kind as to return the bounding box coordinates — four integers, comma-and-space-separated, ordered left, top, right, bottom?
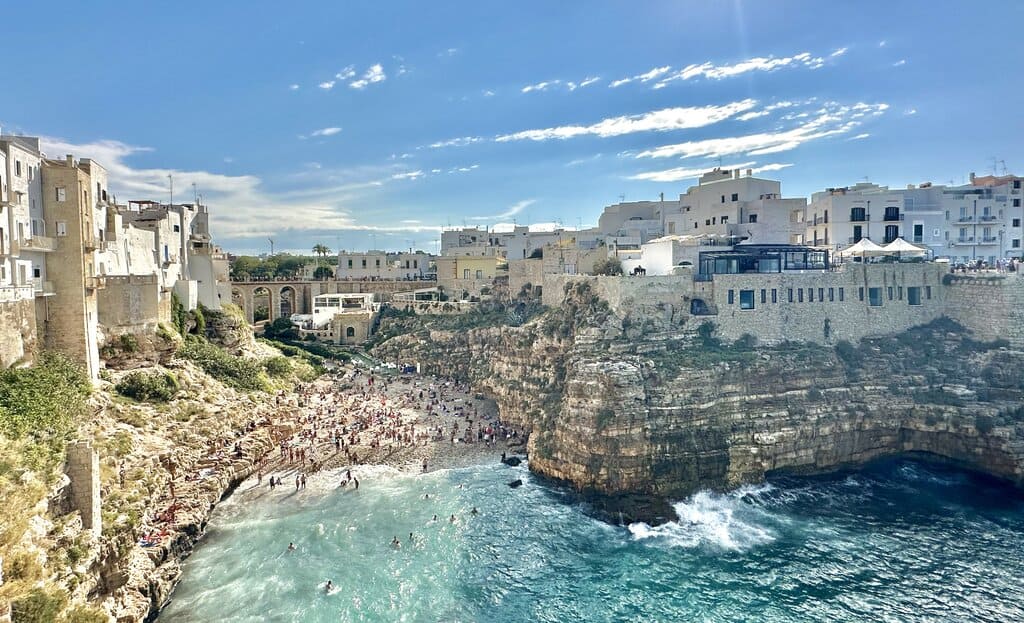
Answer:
160, 462, 1024, 623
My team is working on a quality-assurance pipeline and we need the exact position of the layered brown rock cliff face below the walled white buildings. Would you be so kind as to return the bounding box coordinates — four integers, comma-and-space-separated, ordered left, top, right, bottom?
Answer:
378, 287, 1024, 521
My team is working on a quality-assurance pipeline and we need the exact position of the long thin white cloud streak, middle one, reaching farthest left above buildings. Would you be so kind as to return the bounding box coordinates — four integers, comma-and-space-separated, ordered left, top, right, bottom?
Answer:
495, 99, 757, 142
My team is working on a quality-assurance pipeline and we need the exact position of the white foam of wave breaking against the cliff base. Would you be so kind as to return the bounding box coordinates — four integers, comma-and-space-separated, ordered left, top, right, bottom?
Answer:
629, 487, 775, 551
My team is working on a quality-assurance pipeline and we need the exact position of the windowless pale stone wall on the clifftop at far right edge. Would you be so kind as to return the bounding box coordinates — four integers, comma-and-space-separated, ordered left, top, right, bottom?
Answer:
945, 273, 1024, 348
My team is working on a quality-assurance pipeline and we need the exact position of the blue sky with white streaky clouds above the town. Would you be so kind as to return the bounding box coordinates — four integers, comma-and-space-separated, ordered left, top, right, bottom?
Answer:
0, 0, 1024, 253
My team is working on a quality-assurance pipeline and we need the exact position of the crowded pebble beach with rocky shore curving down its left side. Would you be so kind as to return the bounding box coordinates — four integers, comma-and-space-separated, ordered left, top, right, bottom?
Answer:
118, 367, 525, 623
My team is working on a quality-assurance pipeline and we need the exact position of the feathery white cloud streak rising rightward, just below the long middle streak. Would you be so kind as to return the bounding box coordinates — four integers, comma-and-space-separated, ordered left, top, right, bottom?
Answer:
636, 102, 889, 158
